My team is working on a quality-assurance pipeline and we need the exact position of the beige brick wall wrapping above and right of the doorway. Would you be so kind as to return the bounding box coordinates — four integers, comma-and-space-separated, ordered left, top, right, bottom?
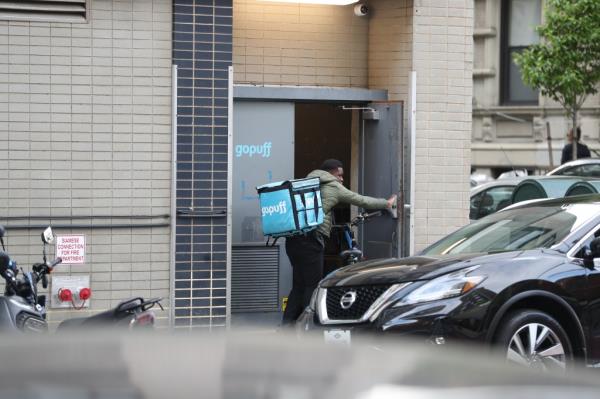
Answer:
234, 0, 473, 250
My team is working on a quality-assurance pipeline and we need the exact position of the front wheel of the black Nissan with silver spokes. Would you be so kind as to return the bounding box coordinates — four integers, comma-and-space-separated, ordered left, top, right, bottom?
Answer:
497, 309, 573, 372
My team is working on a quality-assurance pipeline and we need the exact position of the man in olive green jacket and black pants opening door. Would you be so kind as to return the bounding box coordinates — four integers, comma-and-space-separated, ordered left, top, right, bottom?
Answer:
282, 159, 396, 326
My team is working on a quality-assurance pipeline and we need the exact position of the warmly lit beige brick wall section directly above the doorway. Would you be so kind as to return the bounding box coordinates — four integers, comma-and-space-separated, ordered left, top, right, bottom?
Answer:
233, 0, 369, 87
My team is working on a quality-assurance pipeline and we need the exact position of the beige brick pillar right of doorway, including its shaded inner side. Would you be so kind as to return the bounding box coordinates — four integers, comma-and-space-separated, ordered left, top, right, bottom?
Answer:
369, 0, 473, 250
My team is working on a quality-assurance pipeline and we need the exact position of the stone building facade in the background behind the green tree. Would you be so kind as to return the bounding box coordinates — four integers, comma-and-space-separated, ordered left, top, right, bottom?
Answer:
472, 0, 600, 177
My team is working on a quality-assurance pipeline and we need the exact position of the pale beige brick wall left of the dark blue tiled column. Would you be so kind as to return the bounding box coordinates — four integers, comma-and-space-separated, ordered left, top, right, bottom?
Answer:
0, 0, 172, 328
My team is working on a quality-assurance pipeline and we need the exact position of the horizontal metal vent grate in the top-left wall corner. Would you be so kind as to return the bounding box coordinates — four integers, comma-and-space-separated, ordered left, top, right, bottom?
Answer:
0, 0, 87, 22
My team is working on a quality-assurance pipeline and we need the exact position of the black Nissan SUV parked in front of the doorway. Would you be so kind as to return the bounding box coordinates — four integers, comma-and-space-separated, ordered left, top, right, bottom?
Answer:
297, 195, 600, 370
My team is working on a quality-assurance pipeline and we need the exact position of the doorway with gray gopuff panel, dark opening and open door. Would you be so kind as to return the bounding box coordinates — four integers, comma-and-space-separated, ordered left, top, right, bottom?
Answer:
228, 88, 402, 328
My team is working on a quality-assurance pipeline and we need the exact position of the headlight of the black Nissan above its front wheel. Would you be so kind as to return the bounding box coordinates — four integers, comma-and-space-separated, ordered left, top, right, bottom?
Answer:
394, 266, 486, 306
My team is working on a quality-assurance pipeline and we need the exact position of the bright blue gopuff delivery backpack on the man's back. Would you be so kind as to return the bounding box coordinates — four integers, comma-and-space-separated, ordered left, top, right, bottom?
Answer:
256, 177, 323, 245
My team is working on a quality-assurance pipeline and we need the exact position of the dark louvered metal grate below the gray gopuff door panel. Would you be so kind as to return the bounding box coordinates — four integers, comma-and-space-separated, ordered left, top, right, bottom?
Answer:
231, 245, 279, 313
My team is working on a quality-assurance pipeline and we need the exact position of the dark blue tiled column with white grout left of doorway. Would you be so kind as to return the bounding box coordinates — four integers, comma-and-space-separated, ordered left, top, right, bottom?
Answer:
173, 0, 232, 329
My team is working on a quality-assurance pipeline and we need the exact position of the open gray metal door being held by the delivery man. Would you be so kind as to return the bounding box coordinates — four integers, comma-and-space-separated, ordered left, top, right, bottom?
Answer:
359, 102, 405, 259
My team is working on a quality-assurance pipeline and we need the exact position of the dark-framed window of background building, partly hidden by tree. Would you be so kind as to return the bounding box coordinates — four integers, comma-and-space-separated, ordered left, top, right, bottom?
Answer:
500, 0, 542, 105
